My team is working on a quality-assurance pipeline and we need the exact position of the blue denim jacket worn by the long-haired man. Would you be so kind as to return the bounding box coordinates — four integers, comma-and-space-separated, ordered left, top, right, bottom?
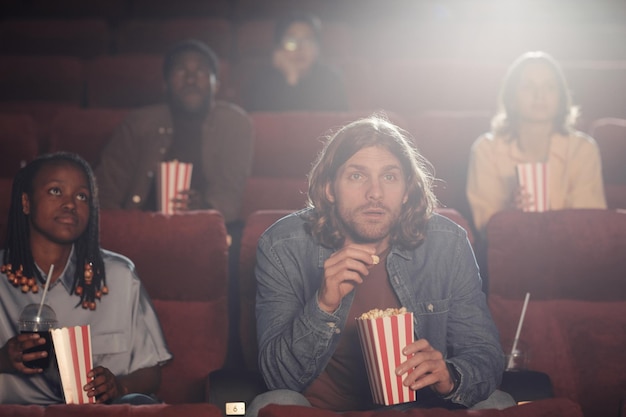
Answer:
256, 208, 504, 407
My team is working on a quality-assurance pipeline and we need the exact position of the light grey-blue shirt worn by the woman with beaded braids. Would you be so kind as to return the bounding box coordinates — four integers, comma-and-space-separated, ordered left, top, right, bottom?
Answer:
0, 250, 172, 404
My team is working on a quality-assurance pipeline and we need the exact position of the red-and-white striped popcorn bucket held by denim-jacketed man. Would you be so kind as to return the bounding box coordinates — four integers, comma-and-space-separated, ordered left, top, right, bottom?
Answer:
357, 313, 416, 405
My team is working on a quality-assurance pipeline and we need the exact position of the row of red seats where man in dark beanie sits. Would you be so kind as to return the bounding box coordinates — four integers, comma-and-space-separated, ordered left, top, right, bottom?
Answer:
0, 109, 626, 226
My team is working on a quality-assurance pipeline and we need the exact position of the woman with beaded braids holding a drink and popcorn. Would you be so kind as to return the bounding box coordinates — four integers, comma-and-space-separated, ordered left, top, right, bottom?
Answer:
0, 153, 172, 404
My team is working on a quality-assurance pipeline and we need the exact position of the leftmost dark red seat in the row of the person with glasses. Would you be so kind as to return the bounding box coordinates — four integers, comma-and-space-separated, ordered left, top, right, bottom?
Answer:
0, 55, 84, 105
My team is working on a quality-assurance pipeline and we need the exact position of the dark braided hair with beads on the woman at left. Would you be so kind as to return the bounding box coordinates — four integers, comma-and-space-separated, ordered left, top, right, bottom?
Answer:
0, 152, 108, 310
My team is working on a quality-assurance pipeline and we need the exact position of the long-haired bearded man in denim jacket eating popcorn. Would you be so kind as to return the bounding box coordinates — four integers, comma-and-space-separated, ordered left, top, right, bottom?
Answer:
248, 117, 514, 416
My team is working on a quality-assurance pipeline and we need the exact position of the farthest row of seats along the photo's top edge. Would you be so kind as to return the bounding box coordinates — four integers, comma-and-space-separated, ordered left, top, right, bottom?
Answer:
3, 0, 626, 23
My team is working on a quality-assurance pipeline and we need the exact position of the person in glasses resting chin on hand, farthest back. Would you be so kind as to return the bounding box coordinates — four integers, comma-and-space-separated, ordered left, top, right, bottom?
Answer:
242, 13, 348, 111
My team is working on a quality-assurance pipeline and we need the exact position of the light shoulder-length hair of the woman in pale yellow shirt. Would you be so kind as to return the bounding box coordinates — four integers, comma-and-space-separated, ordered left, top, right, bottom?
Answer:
491, 52, 578, 137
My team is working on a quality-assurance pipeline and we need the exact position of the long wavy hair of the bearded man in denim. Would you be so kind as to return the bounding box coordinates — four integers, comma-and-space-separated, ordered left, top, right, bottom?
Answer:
307, 116, 437, 249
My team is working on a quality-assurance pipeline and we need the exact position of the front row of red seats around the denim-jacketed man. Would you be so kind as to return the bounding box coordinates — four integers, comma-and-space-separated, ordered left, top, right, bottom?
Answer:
0, 209, 626, 417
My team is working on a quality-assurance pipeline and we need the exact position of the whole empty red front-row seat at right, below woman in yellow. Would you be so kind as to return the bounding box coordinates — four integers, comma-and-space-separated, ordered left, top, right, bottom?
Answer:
487, 209, 626, 416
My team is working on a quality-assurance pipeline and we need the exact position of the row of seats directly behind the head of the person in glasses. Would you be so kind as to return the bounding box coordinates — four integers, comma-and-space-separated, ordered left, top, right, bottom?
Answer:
0, 15, 626, 61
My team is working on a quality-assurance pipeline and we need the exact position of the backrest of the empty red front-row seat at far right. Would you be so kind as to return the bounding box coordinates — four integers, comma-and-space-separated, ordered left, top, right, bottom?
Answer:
487, 209, 626, 301
